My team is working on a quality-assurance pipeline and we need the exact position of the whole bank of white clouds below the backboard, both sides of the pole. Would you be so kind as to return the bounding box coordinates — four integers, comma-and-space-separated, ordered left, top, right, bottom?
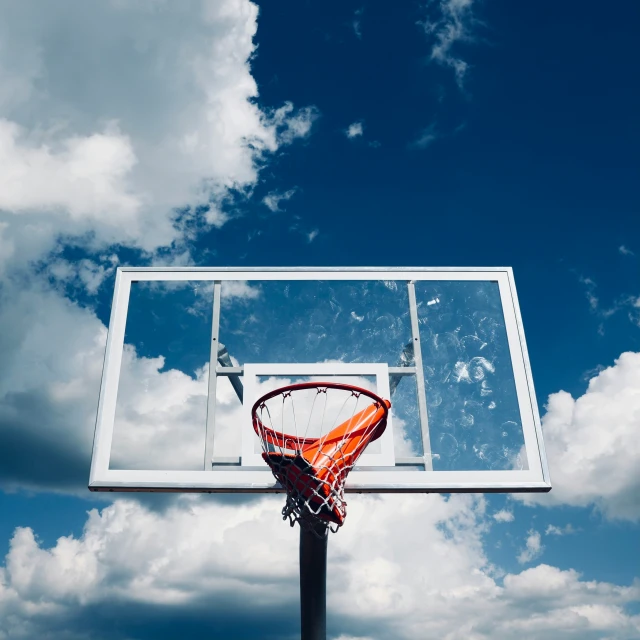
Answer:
0, 495, 640, 640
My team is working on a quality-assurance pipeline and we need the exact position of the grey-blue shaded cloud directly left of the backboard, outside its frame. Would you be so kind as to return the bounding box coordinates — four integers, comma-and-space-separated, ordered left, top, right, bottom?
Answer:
0, 281, 107, 491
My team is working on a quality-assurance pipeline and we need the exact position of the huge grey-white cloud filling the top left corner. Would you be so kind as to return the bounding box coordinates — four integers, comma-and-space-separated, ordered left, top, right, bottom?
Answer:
0, 0, 317, 270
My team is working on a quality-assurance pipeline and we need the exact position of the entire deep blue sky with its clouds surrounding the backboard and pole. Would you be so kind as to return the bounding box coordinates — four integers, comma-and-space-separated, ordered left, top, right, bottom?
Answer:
0, 0, 640, 640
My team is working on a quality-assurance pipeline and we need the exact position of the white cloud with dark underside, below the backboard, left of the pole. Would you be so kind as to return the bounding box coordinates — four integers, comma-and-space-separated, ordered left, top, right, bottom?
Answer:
0, 498, 297, 638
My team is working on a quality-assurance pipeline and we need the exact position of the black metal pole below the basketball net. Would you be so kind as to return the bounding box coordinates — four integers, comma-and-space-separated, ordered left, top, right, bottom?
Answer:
300, 525, 329, 640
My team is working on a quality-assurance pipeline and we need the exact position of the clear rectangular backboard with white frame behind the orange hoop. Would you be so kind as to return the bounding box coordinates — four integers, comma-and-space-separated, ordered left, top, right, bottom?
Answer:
89, 267, 551, 493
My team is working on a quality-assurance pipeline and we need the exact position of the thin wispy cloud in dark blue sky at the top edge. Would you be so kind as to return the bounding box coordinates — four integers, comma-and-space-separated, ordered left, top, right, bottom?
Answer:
421, 0, 475, 88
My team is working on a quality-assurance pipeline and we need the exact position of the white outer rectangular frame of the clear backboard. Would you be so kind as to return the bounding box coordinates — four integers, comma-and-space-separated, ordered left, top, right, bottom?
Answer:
89, 267, 551, 493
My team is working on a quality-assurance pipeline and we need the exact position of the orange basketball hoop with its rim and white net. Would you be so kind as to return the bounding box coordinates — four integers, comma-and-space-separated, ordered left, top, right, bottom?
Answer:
251, 382, 391, 532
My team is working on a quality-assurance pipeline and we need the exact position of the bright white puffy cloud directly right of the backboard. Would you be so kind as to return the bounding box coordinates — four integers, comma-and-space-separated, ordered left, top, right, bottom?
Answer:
513, 352, 640, 522
